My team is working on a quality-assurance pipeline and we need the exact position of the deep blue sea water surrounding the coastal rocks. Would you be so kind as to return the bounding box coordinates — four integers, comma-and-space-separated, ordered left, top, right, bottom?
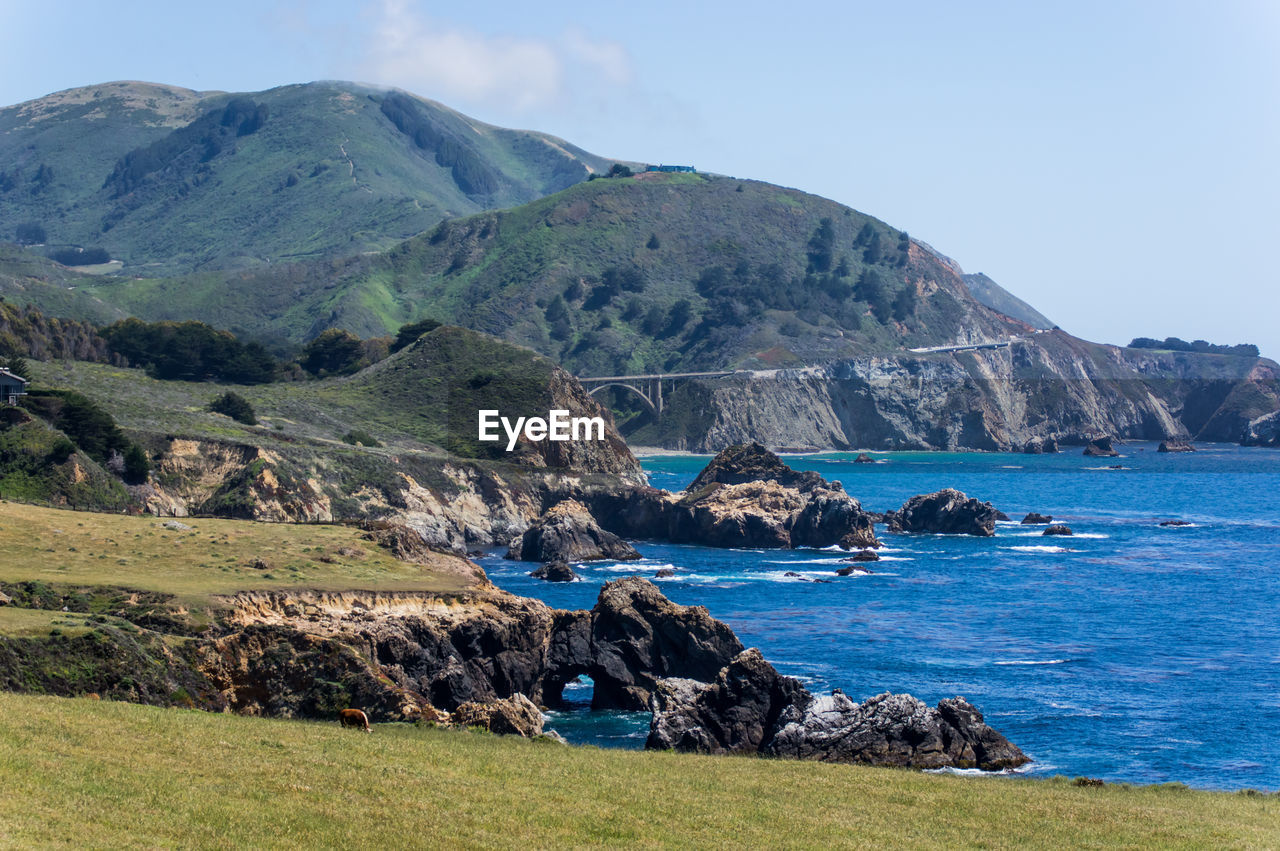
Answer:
481, 443, 1280, 790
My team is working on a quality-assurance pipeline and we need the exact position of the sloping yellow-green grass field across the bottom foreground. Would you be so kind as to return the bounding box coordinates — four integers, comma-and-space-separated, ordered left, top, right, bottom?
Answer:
0, 694, 1280, 848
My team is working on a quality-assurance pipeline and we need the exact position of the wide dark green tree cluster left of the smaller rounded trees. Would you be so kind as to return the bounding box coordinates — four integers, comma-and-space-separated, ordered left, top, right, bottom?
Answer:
100, 319, 280, 384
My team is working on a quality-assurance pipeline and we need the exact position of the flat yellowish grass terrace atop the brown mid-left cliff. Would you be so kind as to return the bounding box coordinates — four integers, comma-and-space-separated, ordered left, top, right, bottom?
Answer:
0, 502, 468, 611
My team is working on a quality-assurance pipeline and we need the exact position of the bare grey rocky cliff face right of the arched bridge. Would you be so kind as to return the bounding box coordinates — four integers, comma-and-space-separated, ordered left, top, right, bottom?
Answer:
659, 331, 1280, 452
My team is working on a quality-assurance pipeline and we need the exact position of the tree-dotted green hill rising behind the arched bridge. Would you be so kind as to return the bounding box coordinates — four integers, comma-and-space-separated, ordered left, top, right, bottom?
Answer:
74, 174, 1009, 375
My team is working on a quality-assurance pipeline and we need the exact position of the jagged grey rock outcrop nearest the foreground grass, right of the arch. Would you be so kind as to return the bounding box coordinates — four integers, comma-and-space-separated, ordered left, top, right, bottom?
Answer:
645, 649, 1029, 770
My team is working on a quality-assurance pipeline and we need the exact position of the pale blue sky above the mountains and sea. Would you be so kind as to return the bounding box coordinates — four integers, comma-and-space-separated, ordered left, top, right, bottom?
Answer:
0, 0, 1280, 358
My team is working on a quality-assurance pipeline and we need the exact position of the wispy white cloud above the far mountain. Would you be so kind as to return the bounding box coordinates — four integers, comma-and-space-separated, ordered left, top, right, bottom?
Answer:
364, 0, 632, 113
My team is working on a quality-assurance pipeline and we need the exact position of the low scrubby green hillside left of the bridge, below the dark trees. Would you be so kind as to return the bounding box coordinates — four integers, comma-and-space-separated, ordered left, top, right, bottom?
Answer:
28, 326, 588, 457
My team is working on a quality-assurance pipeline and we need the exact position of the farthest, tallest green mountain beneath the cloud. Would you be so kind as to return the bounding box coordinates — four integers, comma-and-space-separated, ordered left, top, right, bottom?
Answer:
0, 82, 609, 275
